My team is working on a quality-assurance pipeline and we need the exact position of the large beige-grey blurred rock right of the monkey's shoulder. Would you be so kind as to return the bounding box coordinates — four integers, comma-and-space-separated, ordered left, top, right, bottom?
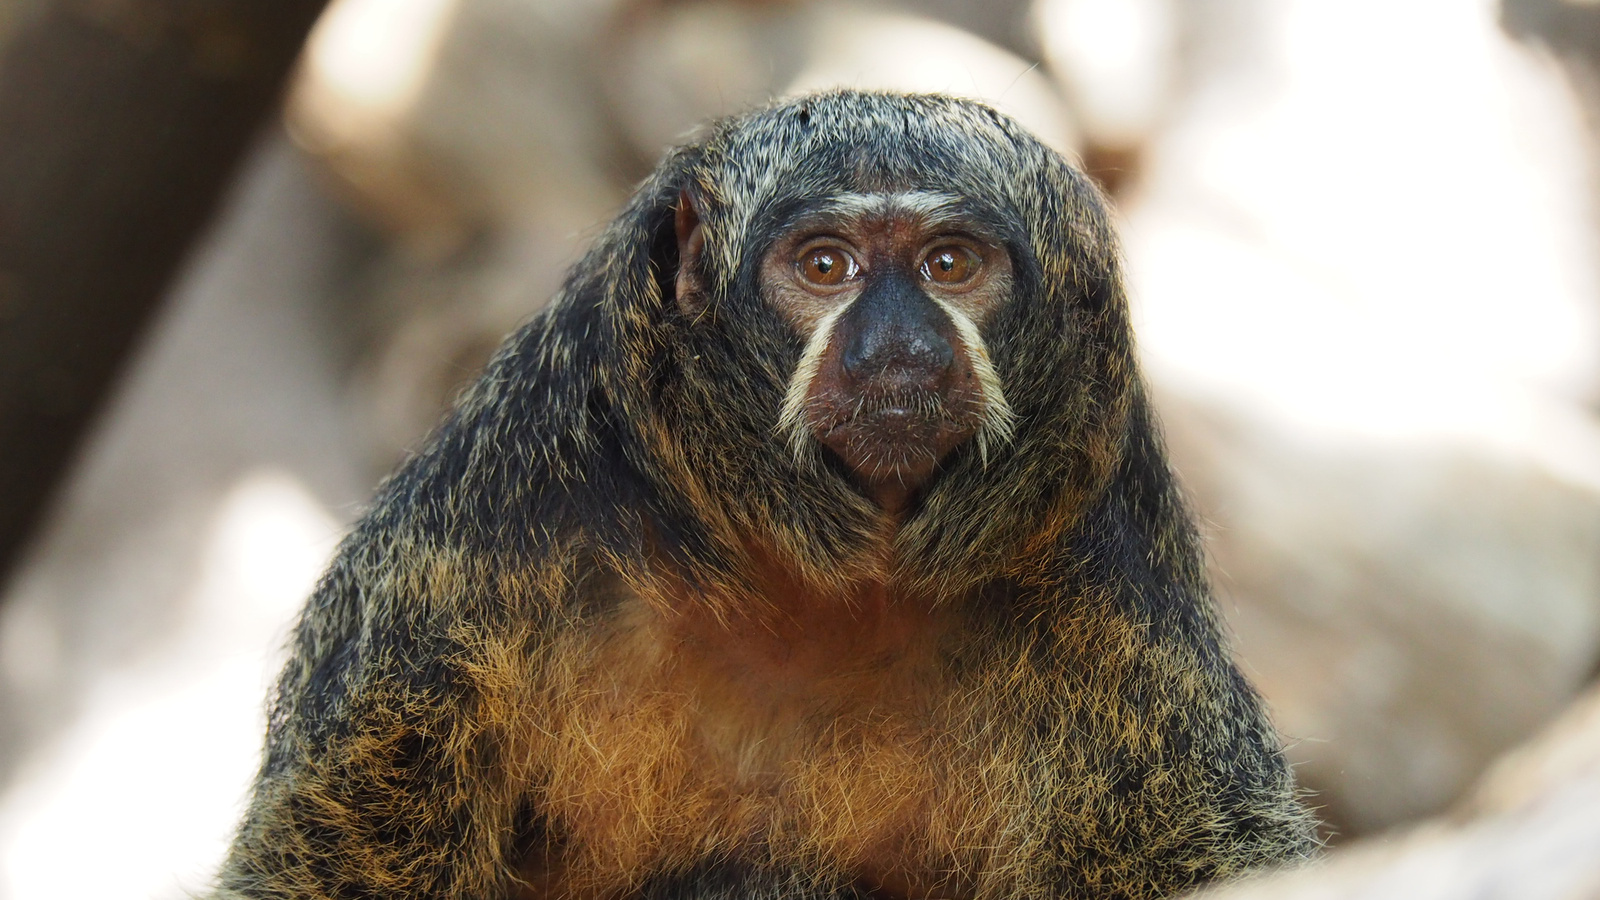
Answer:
1160, 391, 1600, 834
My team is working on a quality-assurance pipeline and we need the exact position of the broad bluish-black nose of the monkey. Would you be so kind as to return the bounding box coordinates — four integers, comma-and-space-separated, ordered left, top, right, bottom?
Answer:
838, 277, 955, 391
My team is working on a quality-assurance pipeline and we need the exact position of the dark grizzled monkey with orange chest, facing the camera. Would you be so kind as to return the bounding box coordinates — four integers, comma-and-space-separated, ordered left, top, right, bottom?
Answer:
216, 91, 1317, 900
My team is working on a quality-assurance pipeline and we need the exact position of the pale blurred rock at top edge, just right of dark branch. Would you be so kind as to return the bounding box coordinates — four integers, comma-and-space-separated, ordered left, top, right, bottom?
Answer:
288, 0, 626, 248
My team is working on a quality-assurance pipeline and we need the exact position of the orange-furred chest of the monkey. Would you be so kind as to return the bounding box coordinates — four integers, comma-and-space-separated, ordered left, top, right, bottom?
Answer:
534, 592, 1013, 897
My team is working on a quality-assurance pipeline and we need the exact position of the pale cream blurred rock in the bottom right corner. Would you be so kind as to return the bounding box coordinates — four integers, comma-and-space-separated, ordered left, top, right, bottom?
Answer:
1194, 690, 1600, 900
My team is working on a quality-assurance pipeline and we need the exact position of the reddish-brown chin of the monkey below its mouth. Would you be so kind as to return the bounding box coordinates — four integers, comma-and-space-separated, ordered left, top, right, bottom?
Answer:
818, 407, 974, 512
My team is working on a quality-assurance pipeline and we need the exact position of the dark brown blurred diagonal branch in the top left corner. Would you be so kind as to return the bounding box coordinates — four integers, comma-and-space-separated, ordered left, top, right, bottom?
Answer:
0, 0, 325, 586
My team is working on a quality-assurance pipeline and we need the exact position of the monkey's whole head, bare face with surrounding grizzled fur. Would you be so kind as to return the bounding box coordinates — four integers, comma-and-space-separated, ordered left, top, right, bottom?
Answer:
588, 91, 1138, 588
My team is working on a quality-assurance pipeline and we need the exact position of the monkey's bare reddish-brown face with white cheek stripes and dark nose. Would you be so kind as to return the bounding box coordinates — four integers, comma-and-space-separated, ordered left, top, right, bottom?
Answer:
732, 192, 1011, 512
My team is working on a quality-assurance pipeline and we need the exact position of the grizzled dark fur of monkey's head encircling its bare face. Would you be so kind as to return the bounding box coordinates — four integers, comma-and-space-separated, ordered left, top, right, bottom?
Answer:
501, 93, 1138, 591
